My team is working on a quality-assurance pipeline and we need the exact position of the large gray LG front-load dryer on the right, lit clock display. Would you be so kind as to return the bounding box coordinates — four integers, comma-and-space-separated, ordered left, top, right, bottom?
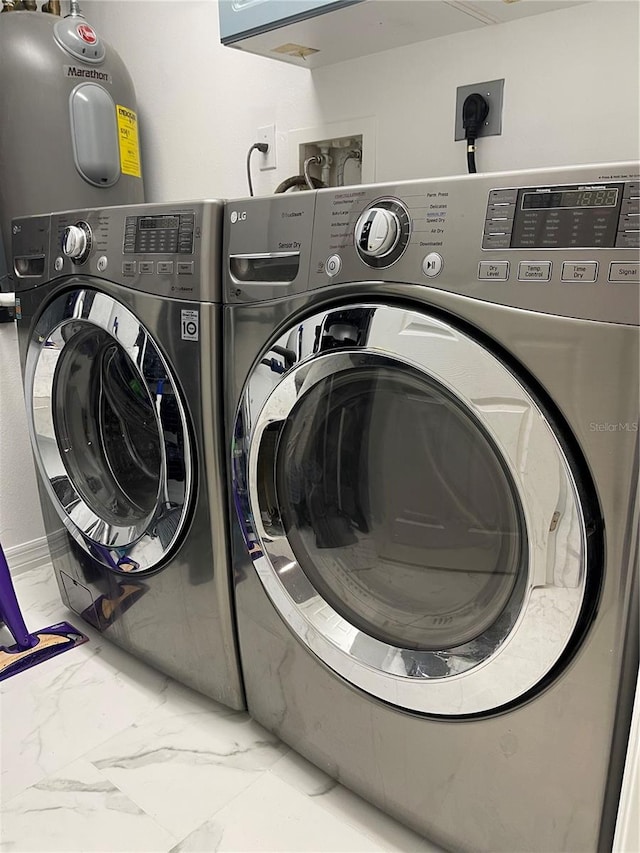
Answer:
224, 164, 640, 853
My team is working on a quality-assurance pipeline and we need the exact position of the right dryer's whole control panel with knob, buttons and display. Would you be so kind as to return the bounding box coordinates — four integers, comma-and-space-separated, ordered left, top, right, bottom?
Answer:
309, 163, 640, 325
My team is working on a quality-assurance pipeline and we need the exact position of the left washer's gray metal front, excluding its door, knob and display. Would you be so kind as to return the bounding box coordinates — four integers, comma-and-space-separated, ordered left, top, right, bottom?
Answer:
13, 201, 244, 709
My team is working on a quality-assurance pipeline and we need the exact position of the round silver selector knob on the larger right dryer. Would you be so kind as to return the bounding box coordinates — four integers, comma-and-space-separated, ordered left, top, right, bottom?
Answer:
354, 198, 411, 267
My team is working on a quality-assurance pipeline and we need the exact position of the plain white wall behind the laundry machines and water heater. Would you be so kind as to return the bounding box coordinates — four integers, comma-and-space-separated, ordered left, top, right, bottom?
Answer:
0, 0, 640, 547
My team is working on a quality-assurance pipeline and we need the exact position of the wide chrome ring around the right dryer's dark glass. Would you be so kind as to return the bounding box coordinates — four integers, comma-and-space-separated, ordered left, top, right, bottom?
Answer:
234, 303, 586, 715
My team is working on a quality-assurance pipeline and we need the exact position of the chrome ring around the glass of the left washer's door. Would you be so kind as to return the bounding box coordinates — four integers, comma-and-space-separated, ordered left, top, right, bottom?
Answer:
25, 288, 193, 573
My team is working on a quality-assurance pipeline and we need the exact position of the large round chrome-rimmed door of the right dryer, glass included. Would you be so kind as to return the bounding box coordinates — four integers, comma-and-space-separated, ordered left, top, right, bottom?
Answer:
234, 304, 586, 715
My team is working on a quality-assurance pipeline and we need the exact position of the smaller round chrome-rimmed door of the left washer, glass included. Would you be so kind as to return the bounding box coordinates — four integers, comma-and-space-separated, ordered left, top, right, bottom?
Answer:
25, 288, 192, 572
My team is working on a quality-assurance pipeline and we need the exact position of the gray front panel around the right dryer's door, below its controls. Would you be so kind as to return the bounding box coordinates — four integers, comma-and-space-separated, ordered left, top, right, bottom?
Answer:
225, 283, 640, 853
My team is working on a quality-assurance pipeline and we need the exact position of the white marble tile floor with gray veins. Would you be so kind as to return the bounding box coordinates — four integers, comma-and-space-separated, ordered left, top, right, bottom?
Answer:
0, 567, 438, 853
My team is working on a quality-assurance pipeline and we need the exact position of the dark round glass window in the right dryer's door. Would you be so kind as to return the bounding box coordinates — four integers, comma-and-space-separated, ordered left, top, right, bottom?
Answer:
275, 362, 527, 651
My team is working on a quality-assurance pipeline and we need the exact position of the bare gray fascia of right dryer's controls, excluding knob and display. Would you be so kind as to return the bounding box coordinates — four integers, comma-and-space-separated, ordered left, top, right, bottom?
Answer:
309, 164, 640, 324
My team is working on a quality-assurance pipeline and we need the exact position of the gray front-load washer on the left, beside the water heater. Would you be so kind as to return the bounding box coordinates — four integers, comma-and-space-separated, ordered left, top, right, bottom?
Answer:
13, 201, 244, 708
